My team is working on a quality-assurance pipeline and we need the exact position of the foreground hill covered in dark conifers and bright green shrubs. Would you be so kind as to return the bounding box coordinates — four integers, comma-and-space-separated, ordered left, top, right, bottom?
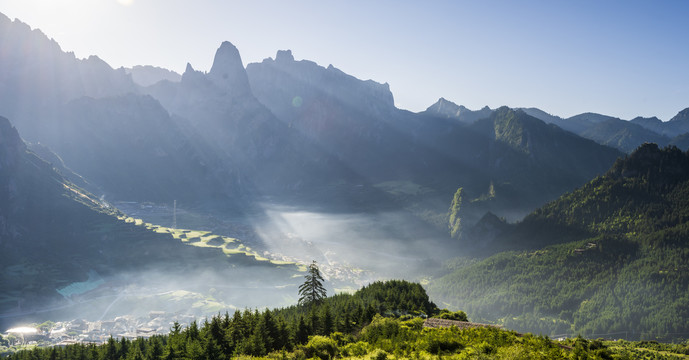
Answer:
7, 281, 689, 360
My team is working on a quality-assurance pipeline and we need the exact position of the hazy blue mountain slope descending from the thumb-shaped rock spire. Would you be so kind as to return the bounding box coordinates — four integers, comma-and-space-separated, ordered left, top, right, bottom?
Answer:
144, 42, 356, 201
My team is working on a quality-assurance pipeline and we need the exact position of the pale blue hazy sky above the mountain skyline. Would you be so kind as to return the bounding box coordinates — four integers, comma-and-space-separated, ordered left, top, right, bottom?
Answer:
0, 0, 689, 120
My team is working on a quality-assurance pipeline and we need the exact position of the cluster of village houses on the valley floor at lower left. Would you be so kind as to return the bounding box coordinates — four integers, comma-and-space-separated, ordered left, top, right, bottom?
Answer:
2, 311, 196, 346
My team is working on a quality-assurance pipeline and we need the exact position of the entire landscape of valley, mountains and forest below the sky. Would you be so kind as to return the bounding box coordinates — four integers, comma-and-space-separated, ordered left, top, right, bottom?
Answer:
0, 4, 689, 360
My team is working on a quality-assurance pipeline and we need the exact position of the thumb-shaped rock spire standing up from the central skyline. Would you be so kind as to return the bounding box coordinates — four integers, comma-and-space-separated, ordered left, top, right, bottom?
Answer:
208, 41, 250, 95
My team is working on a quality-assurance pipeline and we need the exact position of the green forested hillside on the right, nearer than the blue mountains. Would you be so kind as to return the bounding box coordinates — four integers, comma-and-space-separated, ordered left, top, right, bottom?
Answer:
429, 144, 689, 339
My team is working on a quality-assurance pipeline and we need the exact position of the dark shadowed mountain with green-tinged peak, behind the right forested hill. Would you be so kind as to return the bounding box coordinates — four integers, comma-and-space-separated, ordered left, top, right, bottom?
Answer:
456, 107, 620, 221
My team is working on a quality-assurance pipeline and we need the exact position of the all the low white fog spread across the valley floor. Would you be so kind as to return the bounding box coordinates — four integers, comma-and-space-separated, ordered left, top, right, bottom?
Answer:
0, 202, 452, 327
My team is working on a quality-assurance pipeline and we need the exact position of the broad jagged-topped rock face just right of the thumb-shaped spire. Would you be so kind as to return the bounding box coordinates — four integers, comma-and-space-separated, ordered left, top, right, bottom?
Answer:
247, 50, 409, 181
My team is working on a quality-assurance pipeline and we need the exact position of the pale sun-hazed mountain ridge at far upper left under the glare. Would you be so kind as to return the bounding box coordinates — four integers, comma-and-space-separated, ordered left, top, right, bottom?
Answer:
0, 14, 137, 142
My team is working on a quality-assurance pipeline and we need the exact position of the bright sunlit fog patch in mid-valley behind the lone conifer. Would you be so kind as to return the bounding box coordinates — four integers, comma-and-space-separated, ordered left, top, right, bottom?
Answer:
253, 204, 448, 287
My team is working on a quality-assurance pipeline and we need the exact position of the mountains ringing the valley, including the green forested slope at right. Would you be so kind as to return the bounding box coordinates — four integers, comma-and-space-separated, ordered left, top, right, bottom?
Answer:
0, 10, 689, 336
